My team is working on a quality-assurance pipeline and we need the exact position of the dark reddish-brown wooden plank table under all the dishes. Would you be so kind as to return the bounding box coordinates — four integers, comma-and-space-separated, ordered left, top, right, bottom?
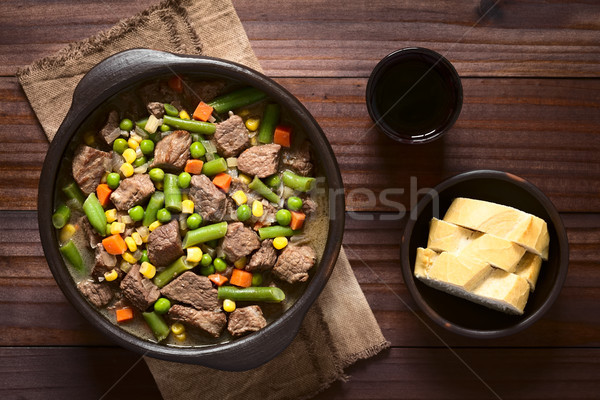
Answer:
0, 0, 600, 399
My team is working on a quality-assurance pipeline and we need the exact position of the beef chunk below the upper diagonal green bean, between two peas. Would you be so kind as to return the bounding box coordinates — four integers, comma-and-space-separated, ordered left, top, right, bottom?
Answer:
150, 131, 192, 172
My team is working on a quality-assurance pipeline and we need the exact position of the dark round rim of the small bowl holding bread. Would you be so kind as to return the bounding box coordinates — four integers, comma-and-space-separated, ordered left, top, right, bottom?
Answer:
400, 170, 569, 339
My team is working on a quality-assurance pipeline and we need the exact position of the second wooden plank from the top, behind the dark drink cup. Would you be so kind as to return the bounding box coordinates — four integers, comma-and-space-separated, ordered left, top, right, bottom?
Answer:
0, 78, 600, 212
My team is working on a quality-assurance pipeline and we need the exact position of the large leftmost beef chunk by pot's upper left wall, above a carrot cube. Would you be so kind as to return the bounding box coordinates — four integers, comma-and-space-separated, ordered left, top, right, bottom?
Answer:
73, 145, 111, 196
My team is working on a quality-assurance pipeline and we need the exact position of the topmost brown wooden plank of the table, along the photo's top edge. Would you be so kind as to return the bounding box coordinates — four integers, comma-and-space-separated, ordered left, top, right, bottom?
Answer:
0, 0, 600, 77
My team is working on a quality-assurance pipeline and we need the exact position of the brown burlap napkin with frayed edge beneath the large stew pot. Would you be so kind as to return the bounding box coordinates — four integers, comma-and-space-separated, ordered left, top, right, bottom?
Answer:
18, 0, 389, 400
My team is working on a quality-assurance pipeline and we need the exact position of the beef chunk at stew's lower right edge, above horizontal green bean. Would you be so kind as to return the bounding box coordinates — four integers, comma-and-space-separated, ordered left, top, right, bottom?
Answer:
273, 245, 317, 283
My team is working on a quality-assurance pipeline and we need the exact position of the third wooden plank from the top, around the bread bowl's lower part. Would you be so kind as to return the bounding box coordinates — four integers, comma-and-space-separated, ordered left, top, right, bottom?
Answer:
0, 211, 600, 347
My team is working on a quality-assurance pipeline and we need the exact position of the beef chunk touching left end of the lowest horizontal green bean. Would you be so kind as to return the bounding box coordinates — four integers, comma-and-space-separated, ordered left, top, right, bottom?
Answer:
160, 271, 219, 311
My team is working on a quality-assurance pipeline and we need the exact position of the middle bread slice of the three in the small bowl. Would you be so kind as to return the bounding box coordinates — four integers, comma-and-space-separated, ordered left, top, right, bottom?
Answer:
427, 218, 525, 272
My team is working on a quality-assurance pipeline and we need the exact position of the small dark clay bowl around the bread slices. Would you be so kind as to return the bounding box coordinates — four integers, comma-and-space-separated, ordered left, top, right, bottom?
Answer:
401, 170, 569, 338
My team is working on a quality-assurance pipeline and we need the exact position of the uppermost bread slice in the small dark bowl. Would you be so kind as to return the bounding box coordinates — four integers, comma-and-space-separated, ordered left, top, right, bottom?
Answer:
444, 197, 550, 260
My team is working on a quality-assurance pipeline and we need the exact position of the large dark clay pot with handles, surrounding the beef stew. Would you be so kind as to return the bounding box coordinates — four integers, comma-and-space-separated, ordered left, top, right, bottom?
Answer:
38, 49, 344, 371
